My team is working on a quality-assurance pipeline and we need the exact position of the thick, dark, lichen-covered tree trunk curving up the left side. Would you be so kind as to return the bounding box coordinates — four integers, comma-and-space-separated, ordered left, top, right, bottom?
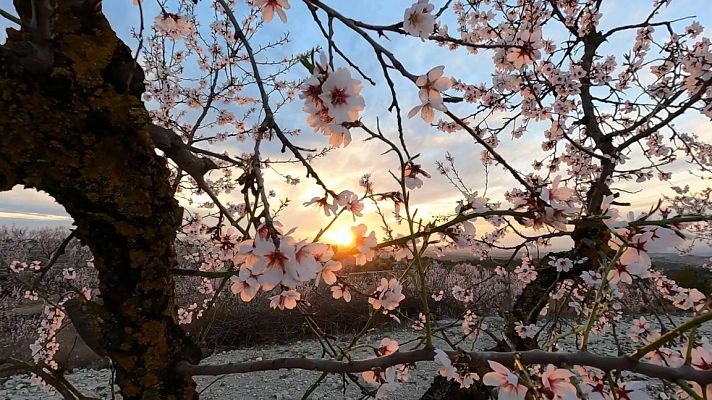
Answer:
0, 0, 200, 400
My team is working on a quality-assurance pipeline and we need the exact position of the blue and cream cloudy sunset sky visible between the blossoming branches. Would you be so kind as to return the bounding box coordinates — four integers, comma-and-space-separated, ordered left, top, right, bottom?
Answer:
0, 0, 712, 253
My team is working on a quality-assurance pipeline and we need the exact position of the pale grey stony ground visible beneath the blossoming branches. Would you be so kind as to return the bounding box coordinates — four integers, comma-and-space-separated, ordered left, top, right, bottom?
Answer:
0, 318, 712, 400
